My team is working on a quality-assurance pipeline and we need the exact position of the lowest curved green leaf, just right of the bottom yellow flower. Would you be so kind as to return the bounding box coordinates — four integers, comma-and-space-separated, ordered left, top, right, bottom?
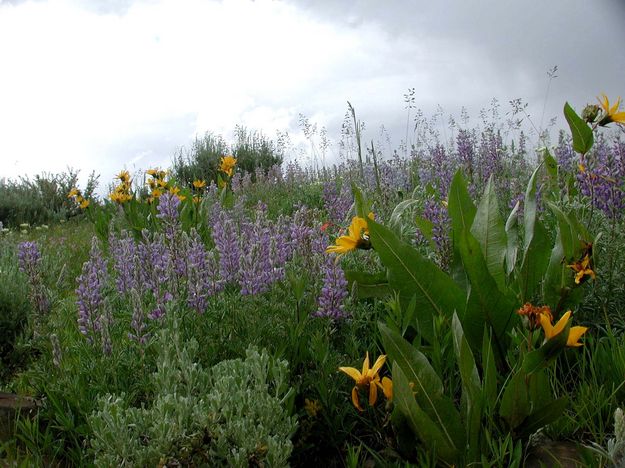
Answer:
393, 363, 463, 464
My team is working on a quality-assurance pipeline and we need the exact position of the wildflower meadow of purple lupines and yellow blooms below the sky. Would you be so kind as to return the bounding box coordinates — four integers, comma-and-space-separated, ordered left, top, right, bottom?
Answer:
0, 97, 625, 467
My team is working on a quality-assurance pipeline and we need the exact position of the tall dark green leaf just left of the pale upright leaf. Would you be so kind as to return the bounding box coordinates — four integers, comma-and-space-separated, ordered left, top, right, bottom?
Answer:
448, 173, 517, 352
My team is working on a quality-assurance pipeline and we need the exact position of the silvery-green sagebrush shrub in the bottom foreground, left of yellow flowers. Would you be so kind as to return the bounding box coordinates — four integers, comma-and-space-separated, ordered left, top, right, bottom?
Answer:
89, 331, 297, 467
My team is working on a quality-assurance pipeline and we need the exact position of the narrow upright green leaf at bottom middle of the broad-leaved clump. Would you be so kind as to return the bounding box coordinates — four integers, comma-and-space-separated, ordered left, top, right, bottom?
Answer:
451, 314, 484, 461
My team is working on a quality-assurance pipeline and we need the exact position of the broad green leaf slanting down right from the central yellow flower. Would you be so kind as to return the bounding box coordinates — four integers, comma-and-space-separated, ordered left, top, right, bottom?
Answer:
368, 221, 465, 341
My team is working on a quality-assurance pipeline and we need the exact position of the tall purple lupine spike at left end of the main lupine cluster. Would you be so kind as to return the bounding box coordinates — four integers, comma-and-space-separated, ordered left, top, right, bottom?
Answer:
76, 236, 108, 344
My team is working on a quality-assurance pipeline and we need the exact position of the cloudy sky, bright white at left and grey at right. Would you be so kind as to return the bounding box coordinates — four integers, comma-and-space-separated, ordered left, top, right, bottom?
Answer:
0, 0, 625, 190
